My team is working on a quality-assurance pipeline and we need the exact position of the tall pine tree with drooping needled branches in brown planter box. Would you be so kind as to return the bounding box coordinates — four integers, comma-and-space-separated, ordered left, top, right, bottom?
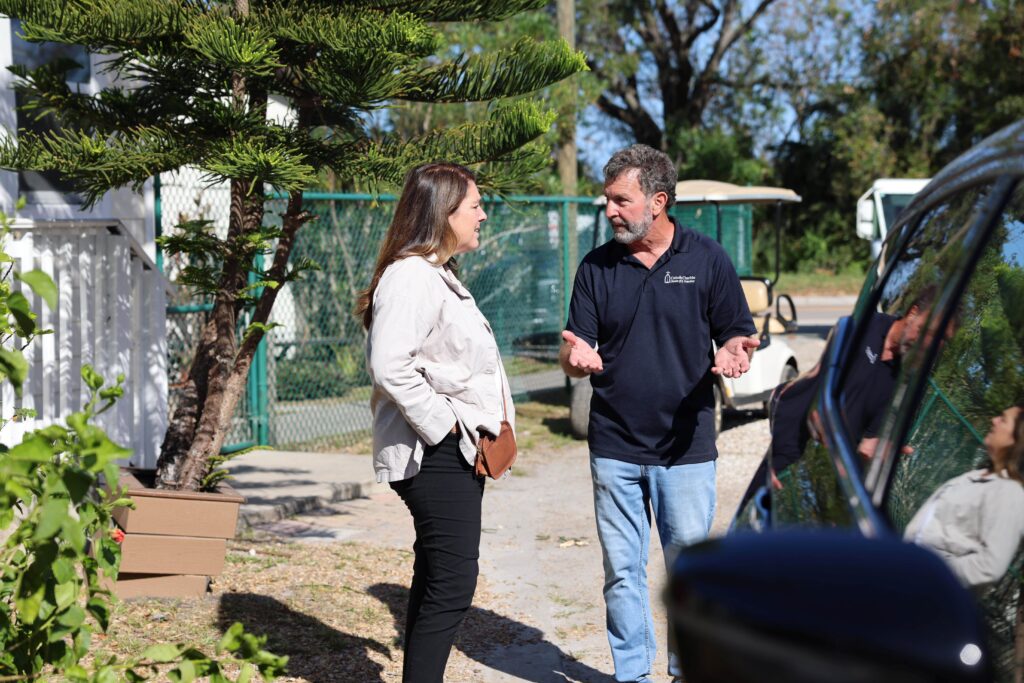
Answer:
0, 0, 586, 489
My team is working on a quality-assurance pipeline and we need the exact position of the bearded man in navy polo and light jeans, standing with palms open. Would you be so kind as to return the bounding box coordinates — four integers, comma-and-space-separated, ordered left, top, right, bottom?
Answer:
559, 144, 759, 682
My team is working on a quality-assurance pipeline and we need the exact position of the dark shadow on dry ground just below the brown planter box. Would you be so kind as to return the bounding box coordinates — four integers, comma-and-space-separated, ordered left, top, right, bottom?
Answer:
217, 593, 391, 683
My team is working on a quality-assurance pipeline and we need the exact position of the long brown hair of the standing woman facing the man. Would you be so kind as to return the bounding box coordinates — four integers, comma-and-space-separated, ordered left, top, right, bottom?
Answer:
355, 162, 476, 330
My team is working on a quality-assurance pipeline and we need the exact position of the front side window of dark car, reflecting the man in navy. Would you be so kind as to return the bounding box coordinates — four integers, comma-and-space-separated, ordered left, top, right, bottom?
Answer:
771, 180, 1008, 536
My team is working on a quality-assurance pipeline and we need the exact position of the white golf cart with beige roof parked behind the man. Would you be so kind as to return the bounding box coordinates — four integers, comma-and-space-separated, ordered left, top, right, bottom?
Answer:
569, 180, 801, 437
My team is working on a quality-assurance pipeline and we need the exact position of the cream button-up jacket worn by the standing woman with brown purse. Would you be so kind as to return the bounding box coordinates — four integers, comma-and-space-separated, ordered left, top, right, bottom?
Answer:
367, 256, 515, 481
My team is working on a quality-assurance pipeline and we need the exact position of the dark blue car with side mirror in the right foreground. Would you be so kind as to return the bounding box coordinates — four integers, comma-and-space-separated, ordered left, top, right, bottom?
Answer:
666, 122, 1024, 683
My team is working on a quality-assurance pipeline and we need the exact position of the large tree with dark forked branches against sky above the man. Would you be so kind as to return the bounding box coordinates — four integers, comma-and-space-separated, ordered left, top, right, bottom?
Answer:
578, 0, 775, 181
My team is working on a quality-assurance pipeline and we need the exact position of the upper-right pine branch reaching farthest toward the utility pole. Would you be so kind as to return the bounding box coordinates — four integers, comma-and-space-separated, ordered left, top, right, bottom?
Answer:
397, 38, 587, 102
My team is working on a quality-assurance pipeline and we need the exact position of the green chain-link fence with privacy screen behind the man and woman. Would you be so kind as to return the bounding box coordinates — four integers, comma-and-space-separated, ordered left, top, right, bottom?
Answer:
159, 176, 751, 451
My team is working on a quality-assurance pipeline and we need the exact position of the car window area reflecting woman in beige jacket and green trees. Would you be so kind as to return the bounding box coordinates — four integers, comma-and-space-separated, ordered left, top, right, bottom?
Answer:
886, 180, 1024, 680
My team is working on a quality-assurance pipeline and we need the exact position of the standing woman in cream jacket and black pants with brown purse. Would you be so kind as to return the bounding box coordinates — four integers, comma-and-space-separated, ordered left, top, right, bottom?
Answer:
356, 163, 515, 683
